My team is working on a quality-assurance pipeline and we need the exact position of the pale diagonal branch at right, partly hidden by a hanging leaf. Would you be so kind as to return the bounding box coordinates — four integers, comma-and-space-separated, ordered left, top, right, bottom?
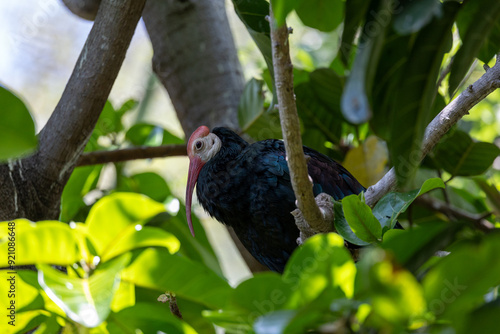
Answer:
365, 54, 500, 207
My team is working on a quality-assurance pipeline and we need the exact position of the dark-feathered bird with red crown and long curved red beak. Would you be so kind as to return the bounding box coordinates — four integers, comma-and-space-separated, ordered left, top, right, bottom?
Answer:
186, 126, 365, 273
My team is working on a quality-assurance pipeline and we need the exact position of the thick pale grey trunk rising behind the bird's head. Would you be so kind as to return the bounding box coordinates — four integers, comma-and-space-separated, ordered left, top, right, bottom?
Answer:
143, 0, 243, 136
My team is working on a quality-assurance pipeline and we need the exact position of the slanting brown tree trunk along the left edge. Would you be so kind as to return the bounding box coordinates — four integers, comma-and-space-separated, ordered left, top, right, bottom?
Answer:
0, 0, 145, 220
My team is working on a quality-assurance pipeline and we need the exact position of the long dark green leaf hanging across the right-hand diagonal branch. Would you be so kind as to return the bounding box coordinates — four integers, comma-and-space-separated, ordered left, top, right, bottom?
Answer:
389, 2, 460, 184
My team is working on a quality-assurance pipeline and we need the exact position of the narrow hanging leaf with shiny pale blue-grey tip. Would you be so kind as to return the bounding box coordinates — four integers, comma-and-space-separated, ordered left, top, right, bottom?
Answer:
341, 0, 392, 124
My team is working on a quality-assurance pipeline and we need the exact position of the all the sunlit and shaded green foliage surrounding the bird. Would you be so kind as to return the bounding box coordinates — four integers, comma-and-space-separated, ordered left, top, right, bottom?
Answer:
0, 0, 500, 333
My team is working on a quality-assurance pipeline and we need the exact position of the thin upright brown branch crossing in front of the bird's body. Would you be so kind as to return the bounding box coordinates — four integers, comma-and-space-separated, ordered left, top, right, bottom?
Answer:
269, 5, 332, 243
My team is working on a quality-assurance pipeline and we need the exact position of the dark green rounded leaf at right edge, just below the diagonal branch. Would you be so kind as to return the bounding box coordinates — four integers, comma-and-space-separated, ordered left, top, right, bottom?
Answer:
434, 130, 500, 176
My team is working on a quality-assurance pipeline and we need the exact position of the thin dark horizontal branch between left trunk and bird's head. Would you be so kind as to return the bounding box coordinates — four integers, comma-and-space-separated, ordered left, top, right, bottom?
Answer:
76, 144, 187, 167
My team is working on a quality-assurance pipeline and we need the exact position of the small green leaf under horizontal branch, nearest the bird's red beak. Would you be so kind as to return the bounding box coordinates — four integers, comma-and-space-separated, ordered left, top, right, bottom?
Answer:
116, 172, 171, 202
